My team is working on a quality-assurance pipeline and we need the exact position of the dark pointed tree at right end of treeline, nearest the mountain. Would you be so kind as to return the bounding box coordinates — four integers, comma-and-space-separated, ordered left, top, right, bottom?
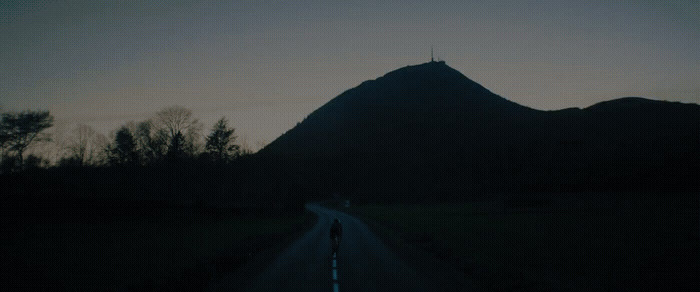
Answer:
206, 117, 240, 162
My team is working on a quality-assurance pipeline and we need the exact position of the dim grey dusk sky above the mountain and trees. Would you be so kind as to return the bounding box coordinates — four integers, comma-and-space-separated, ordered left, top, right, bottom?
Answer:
0, 0, 700, 148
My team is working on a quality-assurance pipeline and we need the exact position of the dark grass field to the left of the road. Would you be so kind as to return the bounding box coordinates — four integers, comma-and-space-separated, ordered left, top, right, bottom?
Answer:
0, 208, 311, 291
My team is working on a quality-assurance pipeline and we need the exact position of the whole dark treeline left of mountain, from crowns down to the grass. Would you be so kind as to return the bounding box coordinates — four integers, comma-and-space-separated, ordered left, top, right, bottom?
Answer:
0, 106, 302, 210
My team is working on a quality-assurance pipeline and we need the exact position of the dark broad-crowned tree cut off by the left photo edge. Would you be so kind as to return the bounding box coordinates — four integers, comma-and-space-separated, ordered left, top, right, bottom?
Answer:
0, 111, 53, 168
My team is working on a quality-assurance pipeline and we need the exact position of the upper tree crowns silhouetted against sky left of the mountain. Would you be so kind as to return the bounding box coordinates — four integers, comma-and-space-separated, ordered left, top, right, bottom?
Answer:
0, 106, 251, 173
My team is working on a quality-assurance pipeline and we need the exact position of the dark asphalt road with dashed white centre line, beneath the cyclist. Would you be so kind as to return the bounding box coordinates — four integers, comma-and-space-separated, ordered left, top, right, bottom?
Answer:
215, 204, 463, 292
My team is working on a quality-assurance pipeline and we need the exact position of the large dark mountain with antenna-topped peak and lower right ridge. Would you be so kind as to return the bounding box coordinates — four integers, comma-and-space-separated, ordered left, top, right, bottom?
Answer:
259, 62, 700, 200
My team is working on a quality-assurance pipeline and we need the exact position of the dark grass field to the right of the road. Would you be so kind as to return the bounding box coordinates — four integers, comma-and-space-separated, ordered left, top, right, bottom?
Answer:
351, 195, 700, 291
